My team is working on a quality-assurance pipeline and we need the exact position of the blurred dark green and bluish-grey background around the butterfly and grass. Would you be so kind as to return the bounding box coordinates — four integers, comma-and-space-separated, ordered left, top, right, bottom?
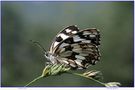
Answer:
2, 1, 134, 87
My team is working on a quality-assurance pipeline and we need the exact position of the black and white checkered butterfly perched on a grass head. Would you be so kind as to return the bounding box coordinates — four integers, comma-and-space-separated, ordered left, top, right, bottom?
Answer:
37, 25, 101, 69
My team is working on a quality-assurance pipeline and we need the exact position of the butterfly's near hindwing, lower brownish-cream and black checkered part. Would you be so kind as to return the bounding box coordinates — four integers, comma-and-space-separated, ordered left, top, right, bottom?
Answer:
57, 43, 100, 68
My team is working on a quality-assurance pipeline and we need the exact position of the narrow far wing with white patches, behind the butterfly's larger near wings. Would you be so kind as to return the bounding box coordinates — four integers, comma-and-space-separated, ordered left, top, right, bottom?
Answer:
49, 25, 79, 53
